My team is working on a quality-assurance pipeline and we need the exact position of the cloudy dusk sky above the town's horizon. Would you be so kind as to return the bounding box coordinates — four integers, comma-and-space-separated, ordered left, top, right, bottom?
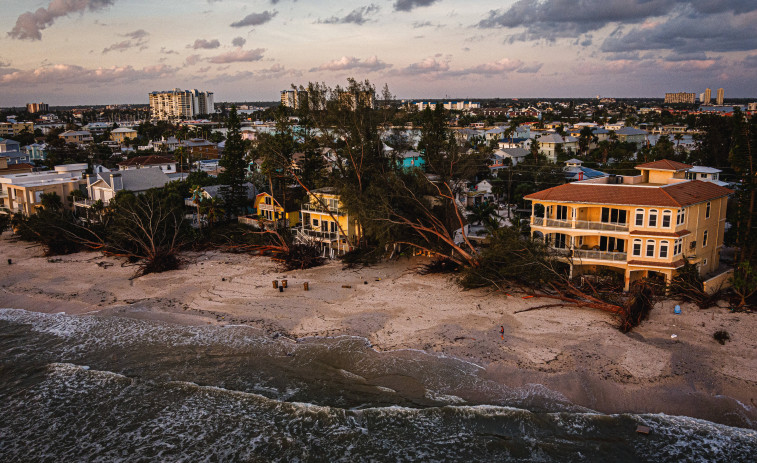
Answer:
0, 0, 757, 107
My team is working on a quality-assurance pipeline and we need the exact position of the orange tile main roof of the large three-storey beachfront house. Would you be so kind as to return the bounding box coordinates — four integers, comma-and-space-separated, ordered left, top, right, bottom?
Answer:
524, 180, 733, 207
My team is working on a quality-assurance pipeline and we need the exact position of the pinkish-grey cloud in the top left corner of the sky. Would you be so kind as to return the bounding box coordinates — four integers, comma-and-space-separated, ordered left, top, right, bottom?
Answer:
8, 0, 115, 40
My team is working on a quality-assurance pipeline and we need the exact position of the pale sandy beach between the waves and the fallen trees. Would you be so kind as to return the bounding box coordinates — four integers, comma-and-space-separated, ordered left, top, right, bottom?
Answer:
0, 233, 757, 428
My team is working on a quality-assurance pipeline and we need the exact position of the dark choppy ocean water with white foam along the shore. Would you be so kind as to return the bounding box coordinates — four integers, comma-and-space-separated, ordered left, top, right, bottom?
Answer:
0, 309, 757, 462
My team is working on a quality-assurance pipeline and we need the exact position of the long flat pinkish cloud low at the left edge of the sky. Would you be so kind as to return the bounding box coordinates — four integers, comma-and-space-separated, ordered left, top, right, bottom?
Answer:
0, 64, 177, 86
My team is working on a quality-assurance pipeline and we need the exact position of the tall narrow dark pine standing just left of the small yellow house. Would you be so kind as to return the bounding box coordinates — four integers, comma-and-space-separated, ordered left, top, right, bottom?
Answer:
219, 105, 247, 215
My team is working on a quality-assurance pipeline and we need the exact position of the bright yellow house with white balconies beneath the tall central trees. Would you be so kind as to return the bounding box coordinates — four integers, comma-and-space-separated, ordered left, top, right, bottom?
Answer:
300, 188, 361, 256
